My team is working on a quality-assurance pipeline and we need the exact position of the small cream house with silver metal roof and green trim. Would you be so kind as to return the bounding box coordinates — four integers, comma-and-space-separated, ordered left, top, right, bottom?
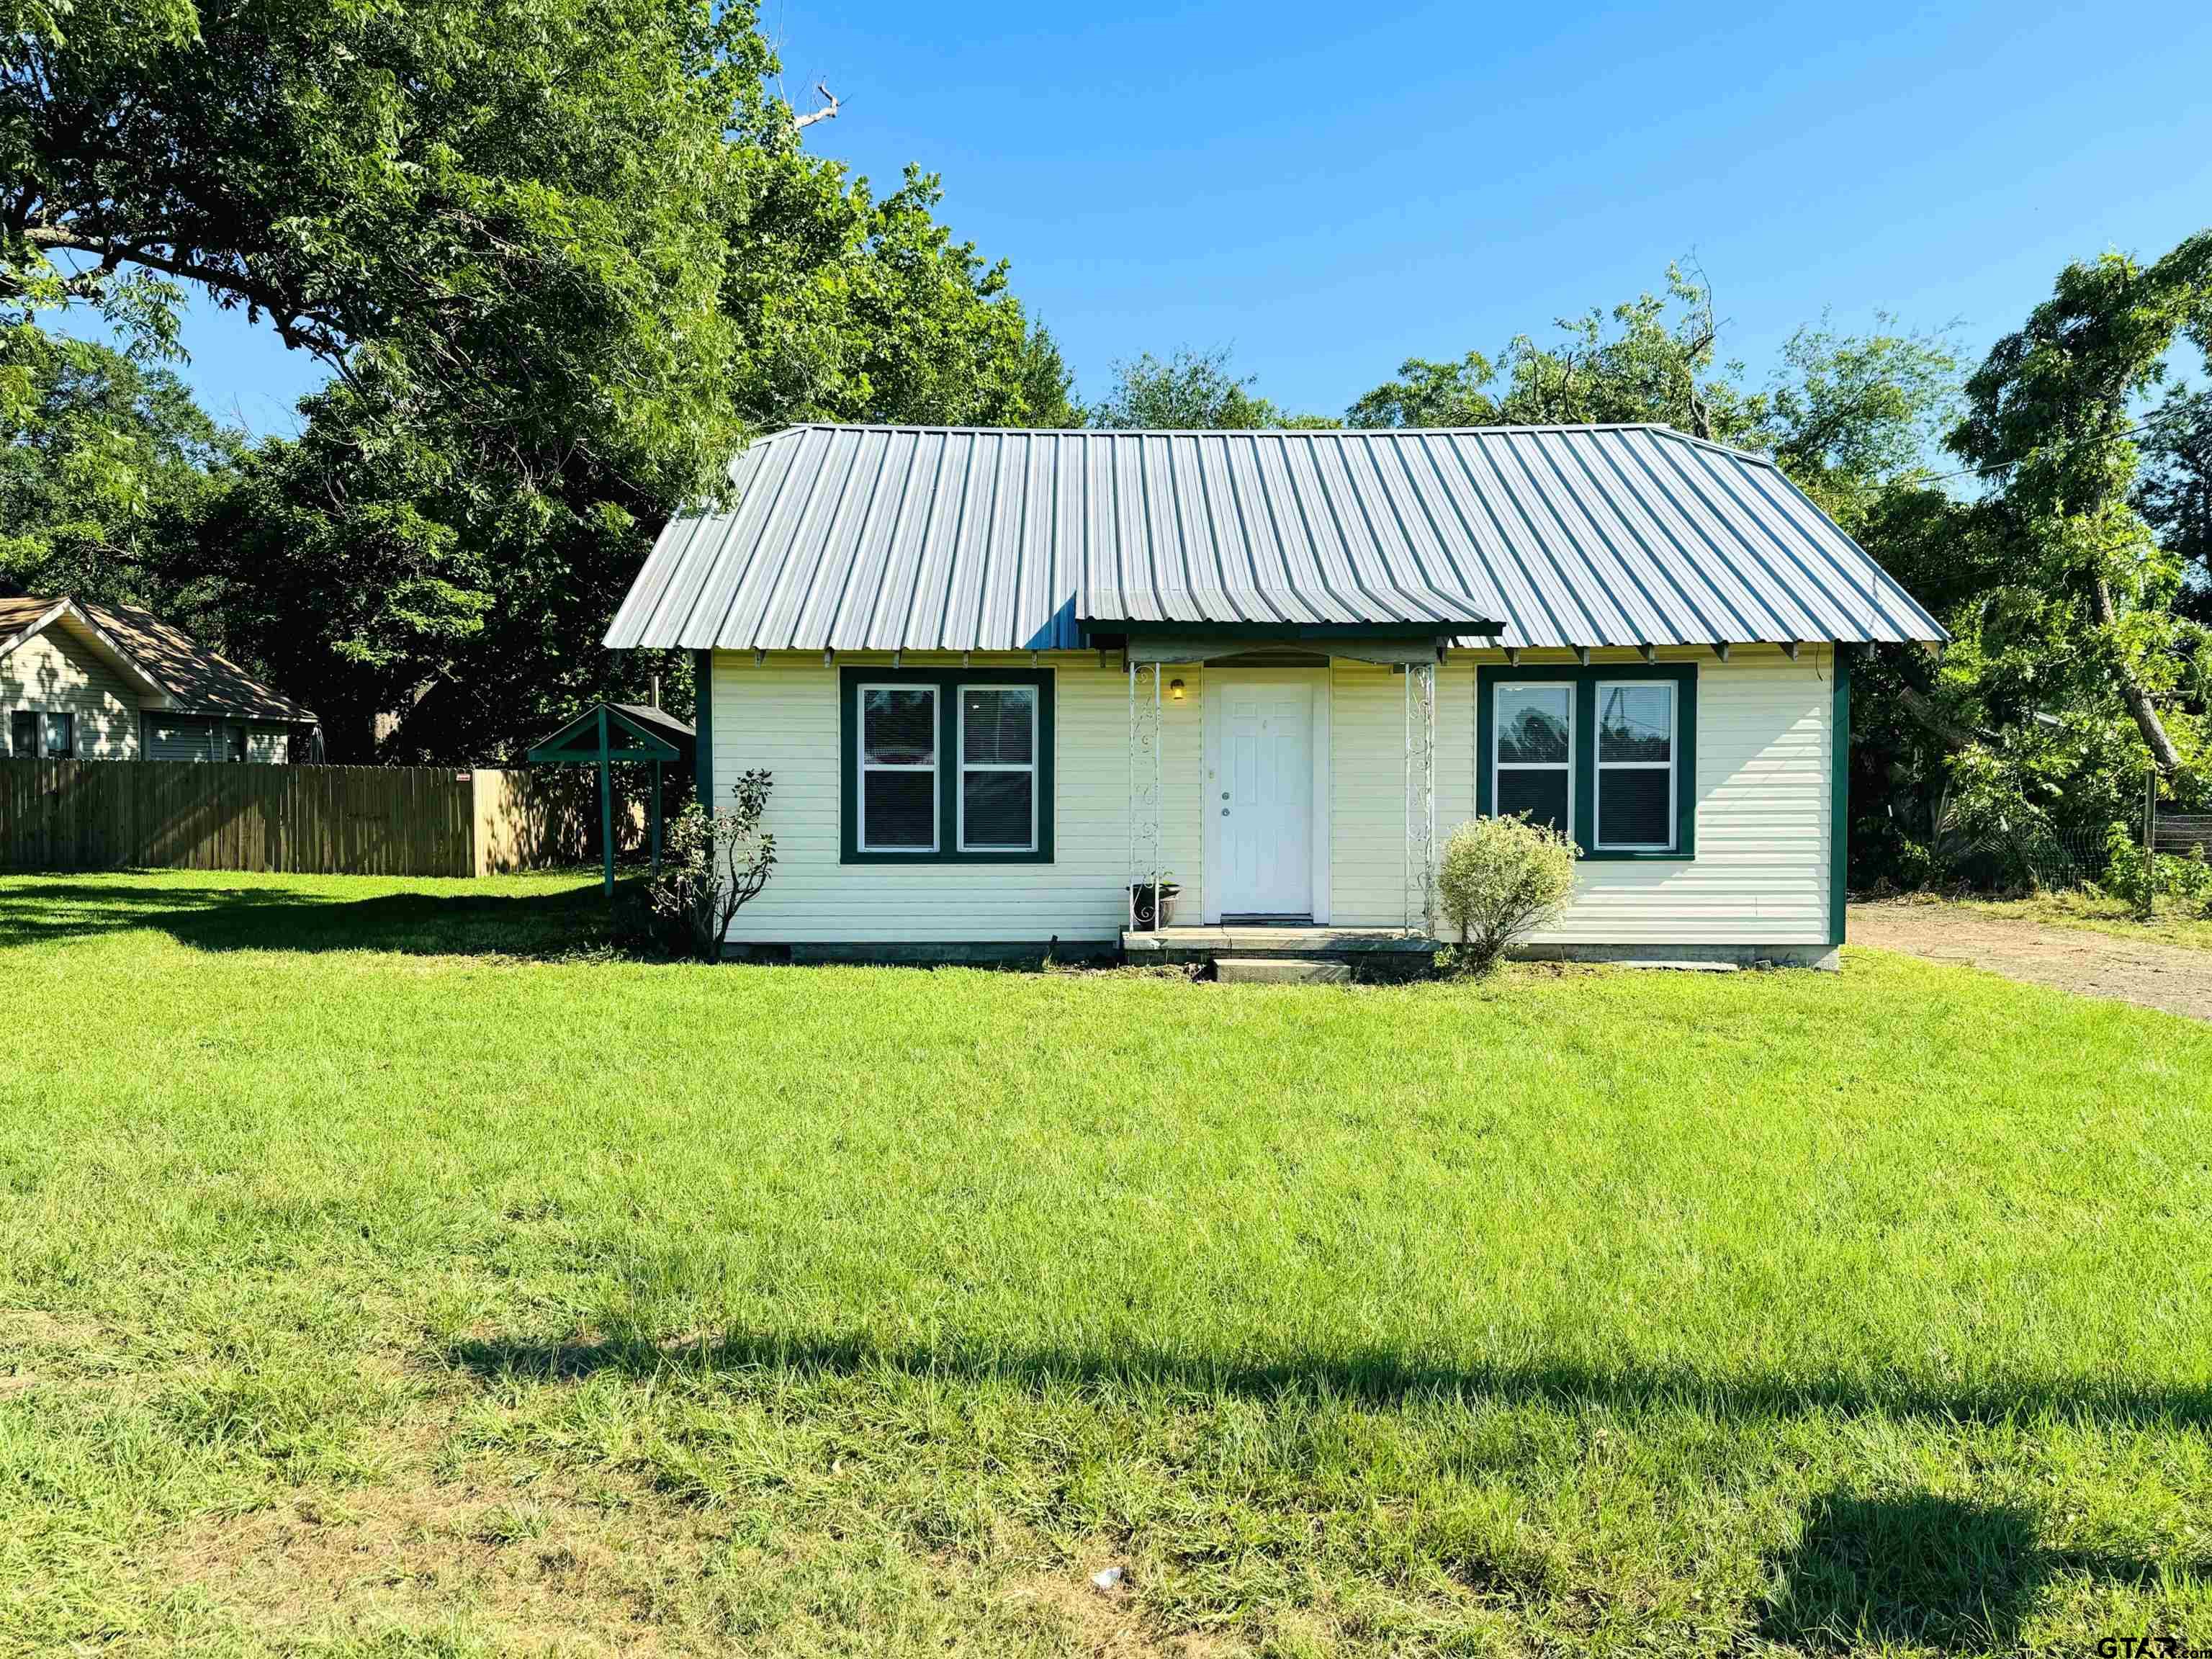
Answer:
606, 427, 1944, 964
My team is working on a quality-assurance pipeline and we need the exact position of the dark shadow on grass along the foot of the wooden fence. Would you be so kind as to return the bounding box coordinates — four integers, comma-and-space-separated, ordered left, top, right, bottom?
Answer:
0, 876, 642, 960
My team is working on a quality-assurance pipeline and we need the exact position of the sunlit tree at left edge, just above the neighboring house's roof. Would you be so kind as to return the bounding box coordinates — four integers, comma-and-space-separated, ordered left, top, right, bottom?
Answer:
0, 323, 239, 602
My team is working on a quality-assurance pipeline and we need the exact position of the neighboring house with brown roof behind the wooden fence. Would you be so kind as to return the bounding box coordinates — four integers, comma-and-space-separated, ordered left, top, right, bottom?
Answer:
0, 597, 316, 761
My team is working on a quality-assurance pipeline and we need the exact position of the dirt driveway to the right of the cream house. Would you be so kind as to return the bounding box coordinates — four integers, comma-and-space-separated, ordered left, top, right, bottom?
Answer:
1849, 902, 2212, 1020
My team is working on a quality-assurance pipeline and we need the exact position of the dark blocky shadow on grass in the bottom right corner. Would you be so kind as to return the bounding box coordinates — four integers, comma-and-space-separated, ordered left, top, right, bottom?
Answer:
1761, 1491, 2185, 1653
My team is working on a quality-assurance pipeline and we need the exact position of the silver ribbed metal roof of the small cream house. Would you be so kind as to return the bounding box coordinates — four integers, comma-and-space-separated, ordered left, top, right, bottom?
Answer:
606, 425, 1944, 650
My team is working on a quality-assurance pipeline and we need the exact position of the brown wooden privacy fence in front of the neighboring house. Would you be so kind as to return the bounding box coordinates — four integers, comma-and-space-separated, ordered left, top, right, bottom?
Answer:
0, 761, 619, 876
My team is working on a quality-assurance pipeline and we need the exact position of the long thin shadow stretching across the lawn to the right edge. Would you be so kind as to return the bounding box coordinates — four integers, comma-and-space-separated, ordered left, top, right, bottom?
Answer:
444, 1334, 2212, 1426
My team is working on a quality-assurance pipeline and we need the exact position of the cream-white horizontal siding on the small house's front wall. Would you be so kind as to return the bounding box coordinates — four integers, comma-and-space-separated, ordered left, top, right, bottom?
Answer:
712, 646, 1834, 945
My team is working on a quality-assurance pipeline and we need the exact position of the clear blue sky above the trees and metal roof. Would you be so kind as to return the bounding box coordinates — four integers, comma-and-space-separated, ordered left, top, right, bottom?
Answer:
112, 0, 2212, 431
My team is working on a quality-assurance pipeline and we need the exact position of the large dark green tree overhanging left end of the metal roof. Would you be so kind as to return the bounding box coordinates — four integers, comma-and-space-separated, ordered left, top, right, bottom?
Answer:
0, 0, 760, 759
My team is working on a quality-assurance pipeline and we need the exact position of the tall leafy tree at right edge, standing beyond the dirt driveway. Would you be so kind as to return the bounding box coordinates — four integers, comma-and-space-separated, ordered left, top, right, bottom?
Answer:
1951, 230, 2212, 774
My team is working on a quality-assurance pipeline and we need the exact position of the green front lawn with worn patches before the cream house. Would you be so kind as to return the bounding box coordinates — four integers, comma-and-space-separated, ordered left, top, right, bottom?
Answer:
0, 873, 2212, 1655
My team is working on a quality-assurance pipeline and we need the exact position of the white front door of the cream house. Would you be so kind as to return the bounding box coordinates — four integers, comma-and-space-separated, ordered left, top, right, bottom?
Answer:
1205, 675, 1323, 916
